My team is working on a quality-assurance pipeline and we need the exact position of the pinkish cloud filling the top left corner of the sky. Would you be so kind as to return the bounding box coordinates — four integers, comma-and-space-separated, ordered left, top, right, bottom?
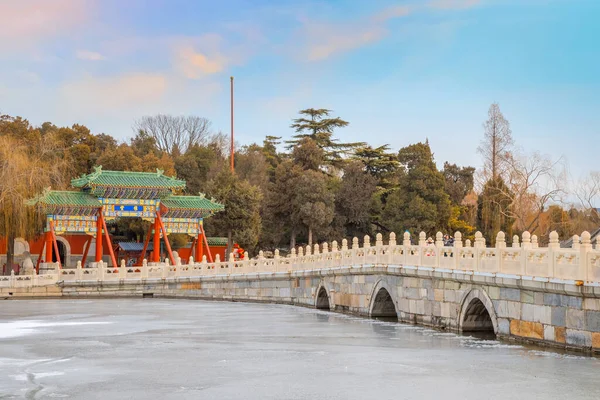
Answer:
0, 0, 92, 48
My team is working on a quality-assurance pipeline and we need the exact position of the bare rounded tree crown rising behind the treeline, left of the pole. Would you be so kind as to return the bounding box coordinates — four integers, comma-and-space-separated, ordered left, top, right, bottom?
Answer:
134, 114, 211, 154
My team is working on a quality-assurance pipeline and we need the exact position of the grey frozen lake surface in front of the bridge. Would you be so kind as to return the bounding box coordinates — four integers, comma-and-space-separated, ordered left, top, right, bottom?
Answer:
0, 299, 600, 400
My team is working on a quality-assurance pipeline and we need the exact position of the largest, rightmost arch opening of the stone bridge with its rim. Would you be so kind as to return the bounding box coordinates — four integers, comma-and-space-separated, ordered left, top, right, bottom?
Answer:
458, 288, 498, 335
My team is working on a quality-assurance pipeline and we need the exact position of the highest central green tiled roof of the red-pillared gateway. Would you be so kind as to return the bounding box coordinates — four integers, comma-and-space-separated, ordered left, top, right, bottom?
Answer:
71, 166, 185, 189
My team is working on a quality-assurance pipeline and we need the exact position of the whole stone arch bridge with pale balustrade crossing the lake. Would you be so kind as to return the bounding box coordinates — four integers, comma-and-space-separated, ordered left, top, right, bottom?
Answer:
0, 232, 600, 352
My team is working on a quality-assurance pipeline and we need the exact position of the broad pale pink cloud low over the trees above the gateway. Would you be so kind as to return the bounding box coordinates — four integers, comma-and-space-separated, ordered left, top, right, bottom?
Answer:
61, 73, 167, 113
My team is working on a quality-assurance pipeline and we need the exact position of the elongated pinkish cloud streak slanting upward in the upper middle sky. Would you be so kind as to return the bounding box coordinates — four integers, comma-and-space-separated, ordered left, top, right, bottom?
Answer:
301, 6, 412, 61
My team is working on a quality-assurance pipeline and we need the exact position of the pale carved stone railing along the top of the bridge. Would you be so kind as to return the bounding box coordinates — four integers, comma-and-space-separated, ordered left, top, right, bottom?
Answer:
0, 232, 600, 287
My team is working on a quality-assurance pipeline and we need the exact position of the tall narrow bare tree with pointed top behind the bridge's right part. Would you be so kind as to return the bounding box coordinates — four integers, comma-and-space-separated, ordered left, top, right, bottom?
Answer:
477, 103, 513, 181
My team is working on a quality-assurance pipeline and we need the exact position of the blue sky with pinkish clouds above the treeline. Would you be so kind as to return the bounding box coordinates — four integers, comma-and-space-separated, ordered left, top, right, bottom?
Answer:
0, 0, 600, 178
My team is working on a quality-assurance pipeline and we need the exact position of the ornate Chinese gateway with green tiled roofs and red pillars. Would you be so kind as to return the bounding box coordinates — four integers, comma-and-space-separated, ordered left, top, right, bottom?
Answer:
21, 167, 224, 270
